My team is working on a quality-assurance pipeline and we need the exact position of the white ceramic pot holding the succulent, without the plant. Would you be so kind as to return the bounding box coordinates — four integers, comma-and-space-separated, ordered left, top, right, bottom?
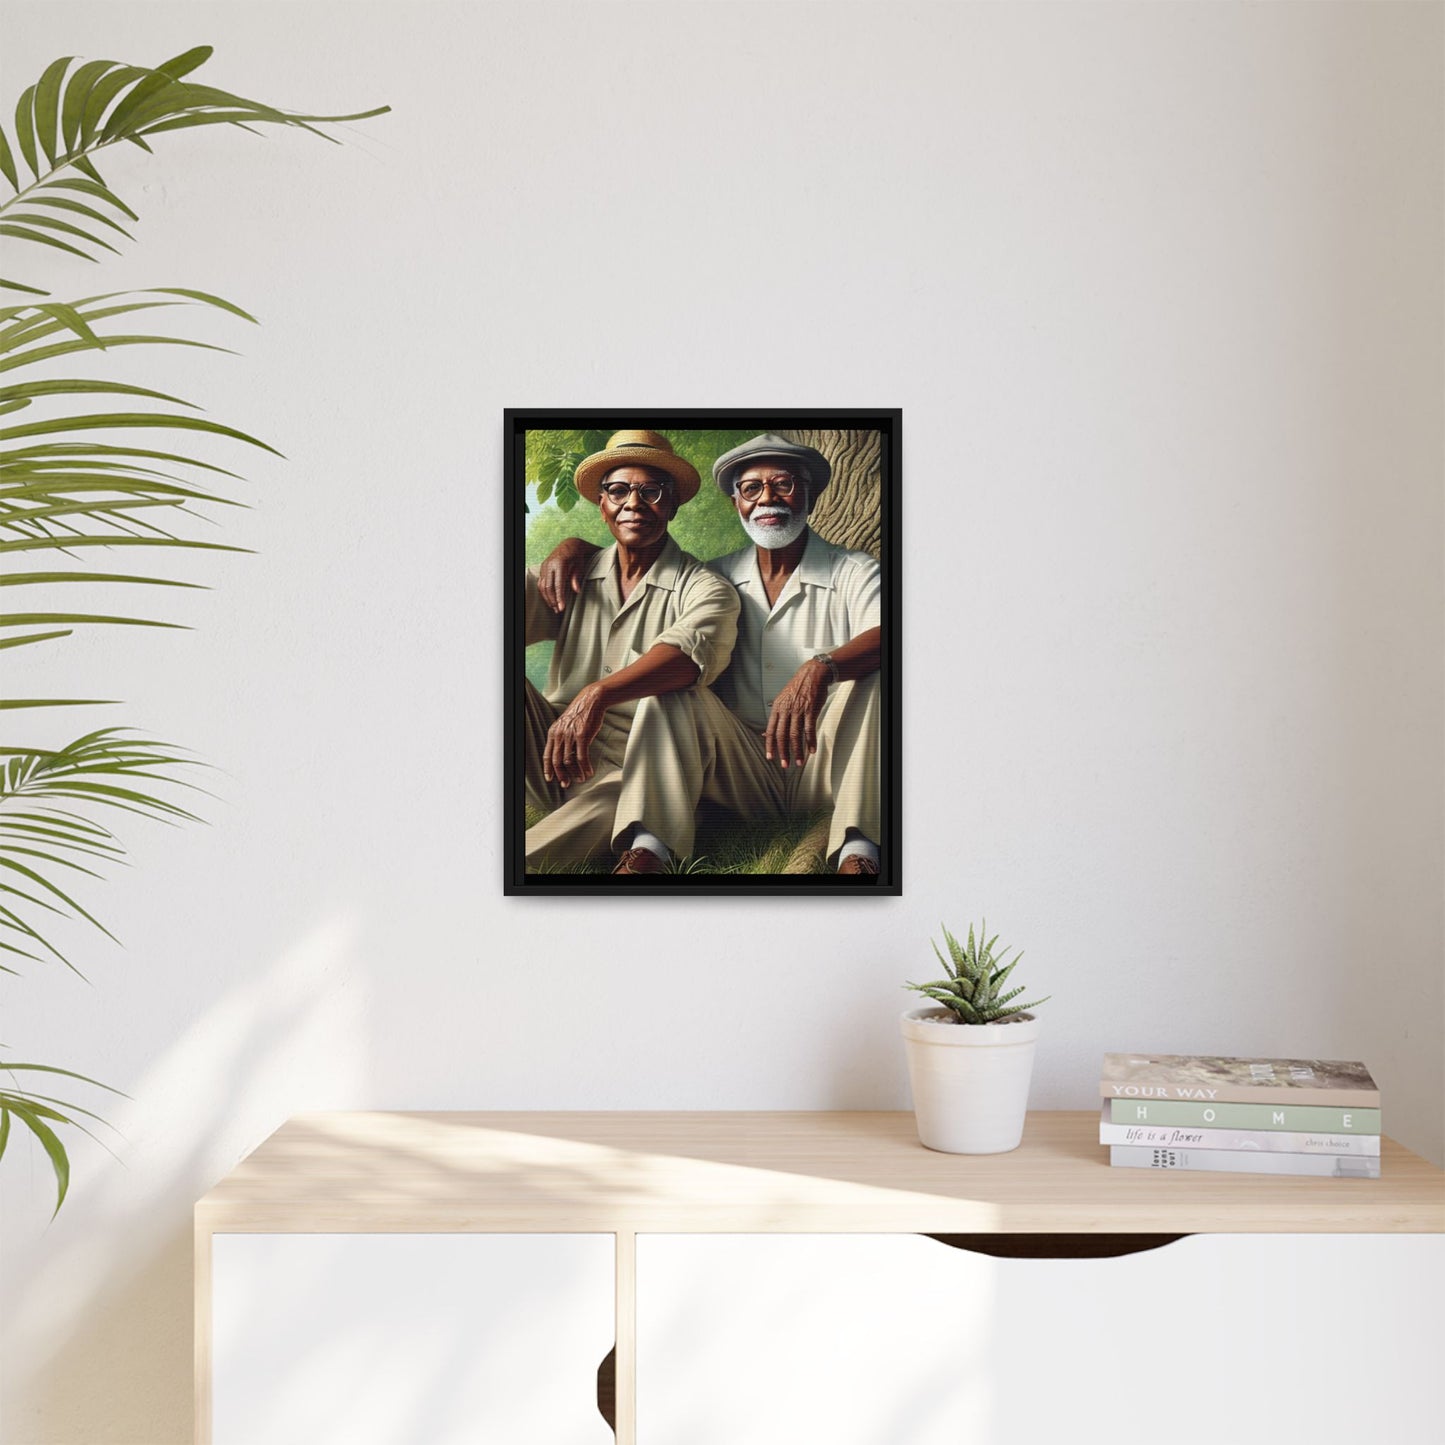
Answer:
902, 1009, 1039, 1155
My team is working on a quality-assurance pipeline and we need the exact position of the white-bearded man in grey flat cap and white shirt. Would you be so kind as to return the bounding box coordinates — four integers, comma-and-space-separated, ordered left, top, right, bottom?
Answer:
542, 434, 881, 877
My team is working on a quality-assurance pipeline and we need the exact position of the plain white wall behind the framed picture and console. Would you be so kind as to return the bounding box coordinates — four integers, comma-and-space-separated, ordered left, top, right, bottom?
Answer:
0, 0, 1445, 1445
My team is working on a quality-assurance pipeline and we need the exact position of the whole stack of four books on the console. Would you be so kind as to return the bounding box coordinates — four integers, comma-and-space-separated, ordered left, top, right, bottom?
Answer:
1098, 1053, 1380, 1179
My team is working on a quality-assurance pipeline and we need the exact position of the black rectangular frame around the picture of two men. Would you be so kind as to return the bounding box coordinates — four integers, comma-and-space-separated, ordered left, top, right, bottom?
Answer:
501, 407, 903, 897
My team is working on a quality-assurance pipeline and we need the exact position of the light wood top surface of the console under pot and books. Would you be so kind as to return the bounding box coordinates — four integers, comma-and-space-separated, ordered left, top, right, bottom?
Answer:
195, 1111, 1445, 1234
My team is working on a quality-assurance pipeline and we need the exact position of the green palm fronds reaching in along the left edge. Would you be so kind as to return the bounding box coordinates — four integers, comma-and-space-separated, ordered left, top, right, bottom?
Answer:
0, 46, 389, 1211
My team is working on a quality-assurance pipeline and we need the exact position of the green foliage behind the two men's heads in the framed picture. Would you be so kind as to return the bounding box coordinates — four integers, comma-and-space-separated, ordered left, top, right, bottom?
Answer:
526, 429, 757, 566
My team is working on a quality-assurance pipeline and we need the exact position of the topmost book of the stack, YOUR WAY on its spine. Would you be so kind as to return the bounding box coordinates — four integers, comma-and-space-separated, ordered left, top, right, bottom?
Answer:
1098, 1053, 1380, 1108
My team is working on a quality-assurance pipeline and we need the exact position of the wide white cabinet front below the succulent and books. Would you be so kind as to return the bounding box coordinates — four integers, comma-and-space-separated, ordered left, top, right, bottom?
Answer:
637, 1234, 1445, 1445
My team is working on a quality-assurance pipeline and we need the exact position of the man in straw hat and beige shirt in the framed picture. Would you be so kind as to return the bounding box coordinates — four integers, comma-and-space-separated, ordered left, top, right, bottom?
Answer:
523, 431, 738, 874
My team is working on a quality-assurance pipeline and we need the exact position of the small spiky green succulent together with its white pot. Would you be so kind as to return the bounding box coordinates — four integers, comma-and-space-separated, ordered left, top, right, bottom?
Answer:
903, 925, 1048, 1155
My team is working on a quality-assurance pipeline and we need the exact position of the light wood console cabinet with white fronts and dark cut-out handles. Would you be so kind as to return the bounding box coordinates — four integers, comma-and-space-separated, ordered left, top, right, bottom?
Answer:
195, 1113, 1445, 1445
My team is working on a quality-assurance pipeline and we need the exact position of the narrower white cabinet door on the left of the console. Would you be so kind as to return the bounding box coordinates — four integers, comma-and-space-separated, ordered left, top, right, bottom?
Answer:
211, 1234, 614, 1445
